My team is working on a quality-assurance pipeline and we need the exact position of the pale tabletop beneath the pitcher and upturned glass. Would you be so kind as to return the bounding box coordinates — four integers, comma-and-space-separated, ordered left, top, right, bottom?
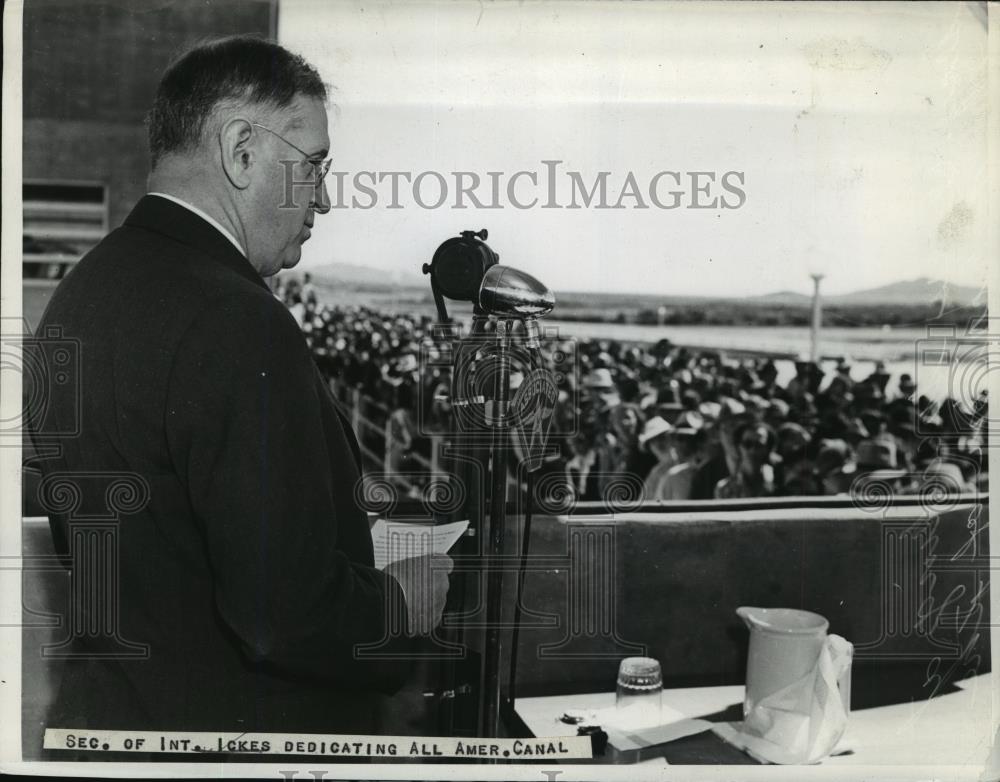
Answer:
516, 673, 993, 768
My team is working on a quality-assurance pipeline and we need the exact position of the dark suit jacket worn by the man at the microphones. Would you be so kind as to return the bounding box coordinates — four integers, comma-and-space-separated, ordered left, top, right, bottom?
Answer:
29, 196, 408, 733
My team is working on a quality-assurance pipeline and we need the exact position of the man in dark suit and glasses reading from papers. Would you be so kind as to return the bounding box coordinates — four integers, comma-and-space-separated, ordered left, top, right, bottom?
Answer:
27, 38, 451, 733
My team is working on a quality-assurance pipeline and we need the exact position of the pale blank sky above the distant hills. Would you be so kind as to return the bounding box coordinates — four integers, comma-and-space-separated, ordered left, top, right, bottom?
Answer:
278, 0, 988, 296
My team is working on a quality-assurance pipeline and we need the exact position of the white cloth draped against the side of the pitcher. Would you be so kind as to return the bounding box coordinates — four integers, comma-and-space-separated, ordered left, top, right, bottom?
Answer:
713, 635, 854, 764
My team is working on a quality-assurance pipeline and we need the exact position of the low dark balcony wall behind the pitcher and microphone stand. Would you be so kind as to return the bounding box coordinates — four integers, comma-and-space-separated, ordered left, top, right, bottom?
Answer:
22, 502, 990, 758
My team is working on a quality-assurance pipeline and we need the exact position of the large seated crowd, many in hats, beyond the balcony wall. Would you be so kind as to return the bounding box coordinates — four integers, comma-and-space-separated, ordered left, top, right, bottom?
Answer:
275, 275, 988, 500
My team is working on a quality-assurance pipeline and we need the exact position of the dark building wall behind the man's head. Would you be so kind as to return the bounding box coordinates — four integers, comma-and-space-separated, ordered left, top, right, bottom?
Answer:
23, 0, 278, 228
